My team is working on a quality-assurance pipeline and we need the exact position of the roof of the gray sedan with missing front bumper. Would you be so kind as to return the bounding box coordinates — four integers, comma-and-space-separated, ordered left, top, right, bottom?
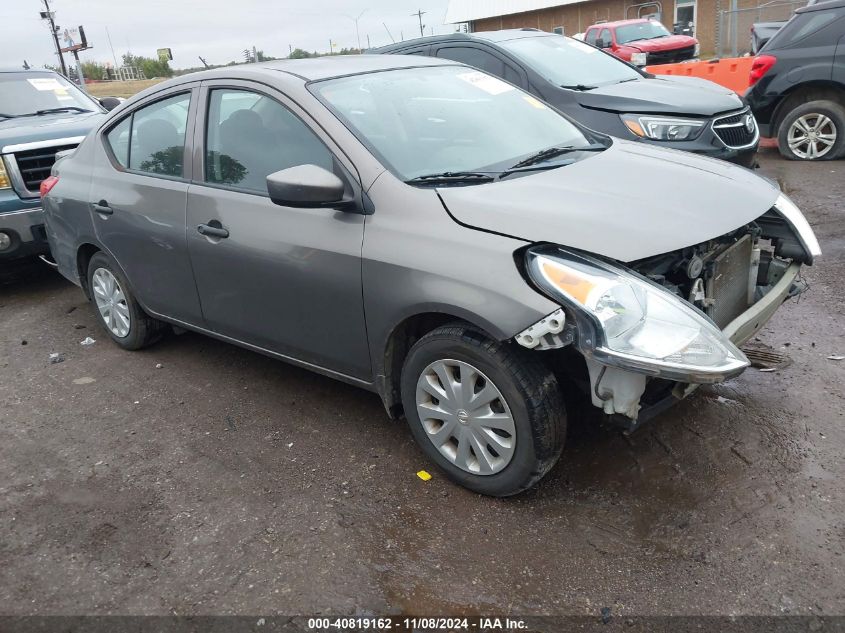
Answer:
164, 55, 455, 85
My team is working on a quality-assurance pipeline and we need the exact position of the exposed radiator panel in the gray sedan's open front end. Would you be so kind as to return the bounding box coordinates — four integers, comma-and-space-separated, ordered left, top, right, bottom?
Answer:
706, 235, 756, 328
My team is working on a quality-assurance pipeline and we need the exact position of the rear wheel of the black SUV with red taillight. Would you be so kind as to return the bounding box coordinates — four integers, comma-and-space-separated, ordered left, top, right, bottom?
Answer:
778, 100, 845, 160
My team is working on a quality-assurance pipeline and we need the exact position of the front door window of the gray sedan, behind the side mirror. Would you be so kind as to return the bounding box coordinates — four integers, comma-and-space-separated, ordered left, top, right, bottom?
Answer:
205, 89, 334, 193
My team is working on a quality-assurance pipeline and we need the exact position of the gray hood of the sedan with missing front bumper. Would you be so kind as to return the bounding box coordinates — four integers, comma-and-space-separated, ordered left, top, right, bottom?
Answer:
438, 139, 780, 262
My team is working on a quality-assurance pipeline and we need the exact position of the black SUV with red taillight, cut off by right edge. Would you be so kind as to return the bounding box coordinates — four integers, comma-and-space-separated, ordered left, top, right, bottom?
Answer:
745, 0, 845, 160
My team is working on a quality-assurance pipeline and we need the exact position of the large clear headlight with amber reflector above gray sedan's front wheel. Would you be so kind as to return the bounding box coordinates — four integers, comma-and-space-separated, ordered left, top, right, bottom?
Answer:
527, 247, 749, 383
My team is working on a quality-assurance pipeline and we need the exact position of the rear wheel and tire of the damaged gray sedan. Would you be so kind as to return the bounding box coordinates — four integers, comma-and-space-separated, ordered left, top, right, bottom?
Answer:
88, 252, 165, 350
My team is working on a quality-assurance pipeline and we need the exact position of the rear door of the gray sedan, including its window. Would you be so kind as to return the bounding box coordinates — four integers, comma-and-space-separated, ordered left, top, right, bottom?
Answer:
89, 82, 202, 323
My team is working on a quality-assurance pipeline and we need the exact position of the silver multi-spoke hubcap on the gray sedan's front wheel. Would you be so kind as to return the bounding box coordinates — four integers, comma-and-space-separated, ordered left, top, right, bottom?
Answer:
417, 360, 516, 475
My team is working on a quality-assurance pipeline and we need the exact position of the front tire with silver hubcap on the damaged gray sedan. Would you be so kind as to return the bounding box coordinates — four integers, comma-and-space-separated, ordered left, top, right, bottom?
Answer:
401, 324, 566, 497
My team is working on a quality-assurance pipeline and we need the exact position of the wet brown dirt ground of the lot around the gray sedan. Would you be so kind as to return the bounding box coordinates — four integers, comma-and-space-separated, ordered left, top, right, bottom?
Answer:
0, 152, 845, 616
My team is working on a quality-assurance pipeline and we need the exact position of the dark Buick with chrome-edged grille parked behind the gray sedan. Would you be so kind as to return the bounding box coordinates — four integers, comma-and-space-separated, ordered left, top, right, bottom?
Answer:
370, 29, 760, 167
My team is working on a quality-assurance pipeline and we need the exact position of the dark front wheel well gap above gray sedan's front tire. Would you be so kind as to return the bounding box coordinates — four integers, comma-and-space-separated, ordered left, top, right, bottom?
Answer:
380, 312, 468, 420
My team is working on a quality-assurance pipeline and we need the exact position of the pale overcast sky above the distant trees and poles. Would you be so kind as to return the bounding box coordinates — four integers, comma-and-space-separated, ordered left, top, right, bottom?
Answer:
0, 0, 454, 68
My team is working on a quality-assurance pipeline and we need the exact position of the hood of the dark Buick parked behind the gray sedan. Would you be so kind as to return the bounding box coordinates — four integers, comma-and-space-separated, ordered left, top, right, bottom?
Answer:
575, 76, 743, 116
